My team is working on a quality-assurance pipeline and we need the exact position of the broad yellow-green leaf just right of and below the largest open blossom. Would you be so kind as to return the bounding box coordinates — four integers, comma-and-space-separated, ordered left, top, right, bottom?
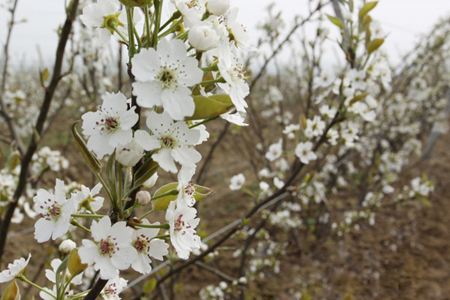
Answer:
187, 95, 233, 120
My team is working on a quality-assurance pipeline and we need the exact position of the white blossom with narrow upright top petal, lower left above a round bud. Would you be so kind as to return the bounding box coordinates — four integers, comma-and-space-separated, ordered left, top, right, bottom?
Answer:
33, 179, 77, 243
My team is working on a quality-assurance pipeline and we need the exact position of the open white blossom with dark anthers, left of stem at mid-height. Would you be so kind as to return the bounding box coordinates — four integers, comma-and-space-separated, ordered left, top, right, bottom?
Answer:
82, 93, 139, 159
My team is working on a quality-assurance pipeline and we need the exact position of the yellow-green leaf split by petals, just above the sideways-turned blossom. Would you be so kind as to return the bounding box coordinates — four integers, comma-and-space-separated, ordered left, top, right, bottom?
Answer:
152, 182, 211, 210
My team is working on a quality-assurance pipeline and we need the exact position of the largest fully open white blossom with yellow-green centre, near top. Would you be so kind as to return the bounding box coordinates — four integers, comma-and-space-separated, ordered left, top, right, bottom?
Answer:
133, 40, 203, 120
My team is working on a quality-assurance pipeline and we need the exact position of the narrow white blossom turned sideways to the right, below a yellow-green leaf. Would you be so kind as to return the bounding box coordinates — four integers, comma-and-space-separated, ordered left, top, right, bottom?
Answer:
166, 201, 202, 259
